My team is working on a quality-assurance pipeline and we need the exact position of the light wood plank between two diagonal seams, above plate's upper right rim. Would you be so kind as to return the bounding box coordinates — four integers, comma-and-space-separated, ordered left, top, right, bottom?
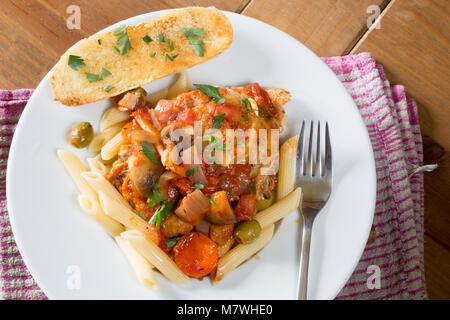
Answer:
242, 0, 389, 56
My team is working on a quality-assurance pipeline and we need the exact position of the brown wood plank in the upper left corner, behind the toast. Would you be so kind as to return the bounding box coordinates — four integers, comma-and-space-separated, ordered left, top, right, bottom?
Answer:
0, 0, 248, 89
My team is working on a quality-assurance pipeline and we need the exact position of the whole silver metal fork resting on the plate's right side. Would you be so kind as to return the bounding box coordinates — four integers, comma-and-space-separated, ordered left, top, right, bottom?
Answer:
295, 120, 332, 300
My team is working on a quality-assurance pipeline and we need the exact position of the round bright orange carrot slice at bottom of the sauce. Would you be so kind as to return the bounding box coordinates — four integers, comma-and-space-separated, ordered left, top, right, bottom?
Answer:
173, 232, 219, 278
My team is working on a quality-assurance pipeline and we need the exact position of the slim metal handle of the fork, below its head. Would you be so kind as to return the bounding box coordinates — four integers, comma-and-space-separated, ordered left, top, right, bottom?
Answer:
297, 208, 315, 300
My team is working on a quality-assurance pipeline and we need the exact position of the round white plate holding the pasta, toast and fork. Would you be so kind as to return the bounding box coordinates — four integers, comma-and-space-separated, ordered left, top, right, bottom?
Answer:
7, 12, 376, 299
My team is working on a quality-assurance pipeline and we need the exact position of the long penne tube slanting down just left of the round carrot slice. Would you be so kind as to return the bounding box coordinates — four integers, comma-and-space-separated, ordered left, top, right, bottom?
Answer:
121, 230, 191, 283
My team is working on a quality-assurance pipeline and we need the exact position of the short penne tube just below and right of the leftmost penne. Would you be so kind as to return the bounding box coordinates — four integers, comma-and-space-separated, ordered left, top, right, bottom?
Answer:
78, 194, 125, 238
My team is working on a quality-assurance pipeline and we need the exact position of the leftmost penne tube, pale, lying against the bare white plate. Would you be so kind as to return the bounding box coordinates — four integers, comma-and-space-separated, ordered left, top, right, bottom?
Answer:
58, 150, 97, 199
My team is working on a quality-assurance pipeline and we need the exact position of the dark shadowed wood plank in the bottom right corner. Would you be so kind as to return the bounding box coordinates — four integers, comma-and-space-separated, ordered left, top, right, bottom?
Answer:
425, 236, 450, 300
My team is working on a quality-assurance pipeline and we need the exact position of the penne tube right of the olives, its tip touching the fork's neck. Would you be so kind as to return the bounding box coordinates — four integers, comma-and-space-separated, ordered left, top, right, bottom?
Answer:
254, 188, 303, 228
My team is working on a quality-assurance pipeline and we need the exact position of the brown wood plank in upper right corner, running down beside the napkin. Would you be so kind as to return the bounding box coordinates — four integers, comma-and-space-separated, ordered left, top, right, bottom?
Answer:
352, 0, 450, 247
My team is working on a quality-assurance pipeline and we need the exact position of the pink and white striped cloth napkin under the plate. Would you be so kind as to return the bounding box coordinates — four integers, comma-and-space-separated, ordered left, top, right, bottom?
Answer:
0, 53, 427, 299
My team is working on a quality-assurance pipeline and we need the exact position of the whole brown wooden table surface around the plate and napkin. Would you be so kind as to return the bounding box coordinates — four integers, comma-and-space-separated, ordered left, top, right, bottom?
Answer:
0, 0, 450, 299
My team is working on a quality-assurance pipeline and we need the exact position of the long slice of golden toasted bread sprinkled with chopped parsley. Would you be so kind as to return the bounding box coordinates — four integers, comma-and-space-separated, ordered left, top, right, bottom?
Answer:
52, 7, 233, 106
